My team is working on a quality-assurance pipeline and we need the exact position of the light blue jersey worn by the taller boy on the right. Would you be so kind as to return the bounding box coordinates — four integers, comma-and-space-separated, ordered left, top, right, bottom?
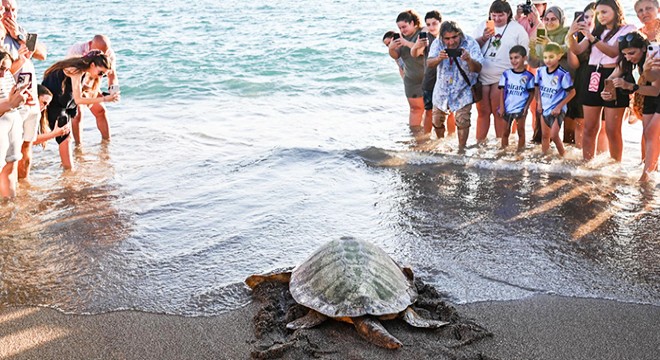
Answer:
536, 66, 573, 116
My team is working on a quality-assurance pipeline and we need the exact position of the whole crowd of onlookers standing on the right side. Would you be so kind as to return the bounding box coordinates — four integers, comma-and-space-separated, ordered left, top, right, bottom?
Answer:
383, 0, 660, 181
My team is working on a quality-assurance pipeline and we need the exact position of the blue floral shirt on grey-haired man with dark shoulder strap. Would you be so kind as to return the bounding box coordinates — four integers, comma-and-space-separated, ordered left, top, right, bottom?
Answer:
429, 36, 484, 113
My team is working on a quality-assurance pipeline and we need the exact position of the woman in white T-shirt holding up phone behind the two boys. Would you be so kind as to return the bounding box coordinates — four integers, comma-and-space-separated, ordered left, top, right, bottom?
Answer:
475, 0, 529, 143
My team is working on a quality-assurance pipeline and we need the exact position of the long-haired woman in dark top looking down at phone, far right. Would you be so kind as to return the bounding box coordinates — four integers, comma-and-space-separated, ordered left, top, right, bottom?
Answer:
602, 31, 660, 181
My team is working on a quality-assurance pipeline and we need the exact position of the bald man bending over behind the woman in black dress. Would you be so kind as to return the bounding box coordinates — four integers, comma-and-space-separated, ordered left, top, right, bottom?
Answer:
67, 35, 119, 144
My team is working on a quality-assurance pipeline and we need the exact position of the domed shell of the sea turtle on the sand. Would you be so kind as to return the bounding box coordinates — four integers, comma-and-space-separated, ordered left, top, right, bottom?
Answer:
289, 237, 417, 317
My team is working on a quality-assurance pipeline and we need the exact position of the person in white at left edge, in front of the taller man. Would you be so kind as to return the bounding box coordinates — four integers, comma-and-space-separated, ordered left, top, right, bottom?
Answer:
0, 48, 29, 199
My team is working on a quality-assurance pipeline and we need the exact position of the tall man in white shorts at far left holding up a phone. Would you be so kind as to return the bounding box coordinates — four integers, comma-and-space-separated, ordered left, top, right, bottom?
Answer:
1, 0, 46, 179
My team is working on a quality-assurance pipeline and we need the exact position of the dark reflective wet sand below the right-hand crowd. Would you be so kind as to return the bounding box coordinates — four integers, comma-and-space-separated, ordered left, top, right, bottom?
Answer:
377, 150, 660, 304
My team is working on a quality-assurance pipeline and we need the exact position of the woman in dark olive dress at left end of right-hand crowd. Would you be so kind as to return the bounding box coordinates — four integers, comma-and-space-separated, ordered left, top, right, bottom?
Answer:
389, 10, 431, 134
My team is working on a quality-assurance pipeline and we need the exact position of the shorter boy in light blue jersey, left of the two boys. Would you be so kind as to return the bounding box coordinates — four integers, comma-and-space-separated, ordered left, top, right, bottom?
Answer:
498, 45, 535, 151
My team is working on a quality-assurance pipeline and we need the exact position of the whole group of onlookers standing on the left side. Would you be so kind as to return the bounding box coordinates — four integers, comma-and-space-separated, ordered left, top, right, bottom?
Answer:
0, 0, 120, 200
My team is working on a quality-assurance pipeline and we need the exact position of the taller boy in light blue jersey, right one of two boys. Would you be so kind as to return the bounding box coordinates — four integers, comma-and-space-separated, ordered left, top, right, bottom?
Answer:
536, 42, 575, 157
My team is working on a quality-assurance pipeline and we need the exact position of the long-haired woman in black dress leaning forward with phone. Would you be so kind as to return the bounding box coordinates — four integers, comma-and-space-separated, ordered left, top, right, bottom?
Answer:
42, 50, 119, 170
